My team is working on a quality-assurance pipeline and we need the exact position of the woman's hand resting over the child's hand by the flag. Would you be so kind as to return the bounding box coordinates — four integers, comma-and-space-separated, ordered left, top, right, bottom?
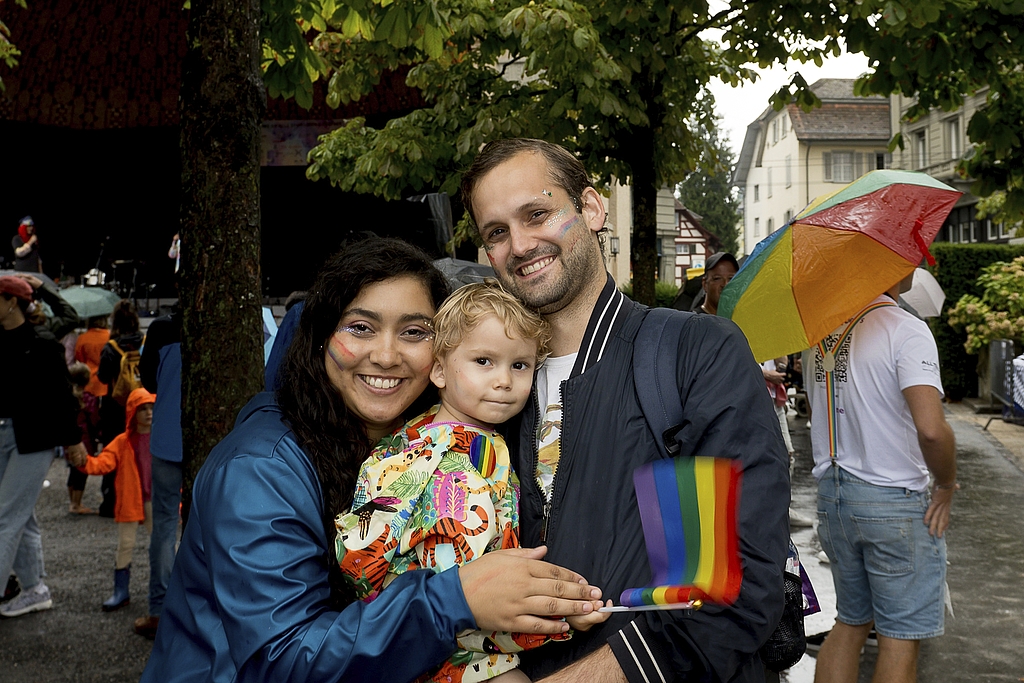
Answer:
459, 547, 601, 635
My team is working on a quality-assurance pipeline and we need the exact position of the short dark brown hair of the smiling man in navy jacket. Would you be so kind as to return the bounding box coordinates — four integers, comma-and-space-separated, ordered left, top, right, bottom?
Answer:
462, 137, 594, 223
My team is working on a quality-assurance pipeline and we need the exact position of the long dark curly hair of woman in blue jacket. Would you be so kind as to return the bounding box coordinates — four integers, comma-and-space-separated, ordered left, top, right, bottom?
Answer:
278, 238, 449, 609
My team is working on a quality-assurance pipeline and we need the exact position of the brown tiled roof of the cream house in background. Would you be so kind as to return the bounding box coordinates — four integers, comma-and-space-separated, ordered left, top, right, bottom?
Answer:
732, 78, 891, 186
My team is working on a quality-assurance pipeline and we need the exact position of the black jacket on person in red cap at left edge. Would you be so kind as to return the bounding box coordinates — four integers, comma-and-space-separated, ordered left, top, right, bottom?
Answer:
0, 323, 82, 453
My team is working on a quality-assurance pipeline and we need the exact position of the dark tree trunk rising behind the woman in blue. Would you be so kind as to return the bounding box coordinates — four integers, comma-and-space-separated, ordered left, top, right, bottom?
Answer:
179, 0, 266, 520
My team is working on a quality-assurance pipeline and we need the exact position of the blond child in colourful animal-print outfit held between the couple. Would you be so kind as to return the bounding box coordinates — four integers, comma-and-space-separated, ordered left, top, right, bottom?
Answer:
336, 284, 608, 683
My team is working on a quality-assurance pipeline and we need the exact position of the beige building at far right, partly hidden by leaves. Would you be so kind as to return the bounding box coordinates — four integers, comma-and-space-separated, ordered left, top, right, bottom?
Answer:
890, 88, 1014, 244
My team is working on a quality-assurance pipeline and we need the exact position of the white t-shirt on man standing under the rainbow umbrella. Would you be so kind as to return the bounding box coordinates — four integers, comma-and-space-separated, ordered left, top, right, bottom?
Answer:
804, 295, 942, 490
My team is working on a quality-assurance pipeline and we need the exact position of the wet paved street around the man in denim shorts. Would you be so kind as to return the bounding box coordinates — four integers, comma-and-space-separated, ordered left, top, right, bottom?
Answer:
782, 404, 1024, 683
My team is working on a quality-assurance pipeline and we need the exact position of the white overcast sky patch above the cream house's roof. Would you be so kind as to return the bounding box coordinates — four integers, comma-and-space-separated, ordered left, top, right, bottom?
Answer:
710, 52, 867, 156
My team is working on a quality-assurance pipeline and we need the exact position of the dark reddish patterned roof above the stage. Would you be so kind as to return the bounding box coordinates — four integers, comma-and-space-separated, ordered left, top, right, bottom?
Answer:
0, 0, 422, 129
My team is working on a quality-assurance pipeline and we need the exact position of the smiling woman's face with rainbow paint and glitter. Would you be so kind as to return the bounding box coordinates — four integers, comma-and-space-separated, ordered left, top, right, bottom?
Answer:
324, 275, 434, 443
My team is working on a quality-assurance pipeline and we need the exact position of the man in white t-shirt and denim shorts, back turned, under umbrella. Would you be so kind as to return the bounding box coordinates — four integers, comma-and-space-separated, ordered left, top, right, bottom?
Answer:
804, 278, 957, 683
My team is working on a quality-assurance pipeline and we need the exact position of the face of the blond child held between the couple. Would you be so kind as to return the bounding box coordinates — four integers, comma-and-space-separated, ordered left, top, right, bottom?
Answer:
430, 315, 538, 427
